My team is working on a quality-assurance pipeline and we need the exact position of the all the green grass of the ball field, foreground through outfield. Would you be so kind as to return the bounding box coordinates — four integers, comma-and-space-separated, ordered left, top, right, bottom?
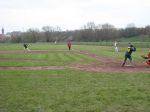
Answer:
0, 43, 150, 112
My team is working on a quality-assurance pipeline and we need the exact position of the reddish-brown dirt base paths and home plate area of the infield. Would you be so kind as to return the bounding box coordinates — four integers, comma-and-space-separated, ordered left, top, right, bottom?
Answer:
0, 50, 150, 73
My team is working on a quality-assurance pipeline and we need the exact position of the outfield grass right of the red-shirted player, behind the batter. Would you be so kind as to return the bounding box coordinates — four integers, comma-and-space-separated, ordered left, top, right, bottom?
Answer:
74, 45, 149, 60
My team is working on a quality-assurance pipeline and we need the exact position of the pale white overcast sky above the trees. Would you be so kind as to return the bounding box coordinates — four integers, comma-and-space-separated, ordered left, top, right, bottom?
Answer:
0, 0, 150, 32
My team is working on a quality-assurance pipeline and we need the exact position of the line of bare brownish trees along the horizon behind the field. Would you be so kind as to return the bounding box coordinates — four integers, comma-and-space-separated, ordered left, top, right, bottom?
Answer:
1, 22, 150, 43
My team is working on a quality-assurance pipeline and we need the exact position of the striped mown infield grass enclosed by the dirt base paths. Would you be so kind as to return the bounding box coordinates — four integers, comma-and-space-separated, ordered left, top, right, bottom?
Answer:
0, 52, 95, 66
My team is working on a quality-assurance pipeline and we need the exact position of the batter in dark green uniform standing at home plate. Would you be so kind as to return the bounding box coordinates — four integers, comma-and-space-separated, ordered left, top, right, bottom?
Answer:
121, 43, 136, 67
